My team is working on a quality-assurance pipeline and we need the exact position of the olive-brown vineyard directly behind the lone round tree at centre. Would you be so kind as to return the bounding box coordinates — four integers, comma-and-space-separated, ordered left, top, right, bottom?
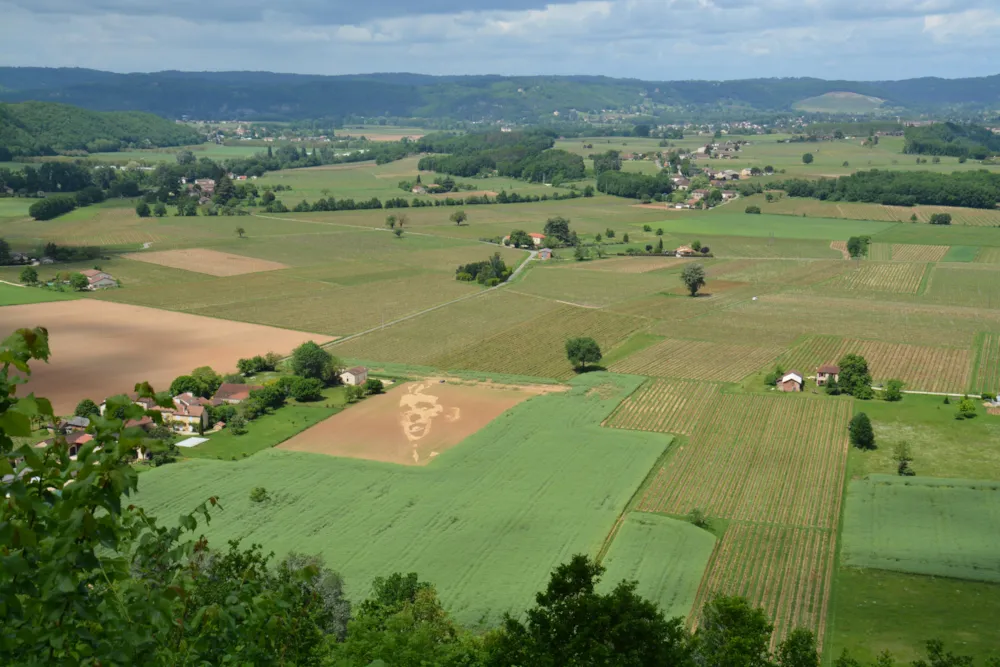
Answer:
430, 306, 643, 379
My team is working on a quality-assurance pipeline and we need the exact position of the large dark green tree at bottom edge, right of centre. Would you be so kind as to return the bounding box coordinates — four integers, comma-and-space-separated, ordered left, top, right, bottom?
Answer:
486, 555, 691, 667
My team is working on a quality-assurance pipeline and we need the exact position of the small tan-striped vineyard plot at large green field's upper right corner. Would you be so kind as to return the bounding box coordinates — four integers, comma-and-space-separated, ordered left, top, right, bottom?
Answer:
605, 380, 720, 435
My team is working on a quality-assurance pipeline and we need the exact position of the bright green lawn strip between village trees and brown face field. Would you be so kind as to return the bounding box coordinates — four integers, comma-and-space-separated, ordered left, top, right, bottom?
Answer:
181, 396, 345, 460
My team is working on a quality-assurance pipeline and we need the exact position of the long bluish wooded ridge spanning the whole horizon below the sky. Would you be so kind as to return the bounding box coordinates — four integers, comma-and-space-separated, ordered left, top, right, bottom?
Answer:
0, 67, 1000, 121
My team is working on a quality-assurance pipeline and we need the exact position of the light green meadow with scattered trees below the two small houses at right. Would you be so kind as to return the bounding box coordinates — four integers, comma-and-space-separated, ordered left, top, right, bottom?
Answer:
850, 394, 1000, 480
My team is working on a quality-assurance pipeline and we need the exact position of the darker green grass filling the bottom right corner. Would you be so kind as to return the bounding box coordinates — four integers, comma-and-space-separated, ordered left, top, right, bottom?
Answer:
825, 568, 1000, 664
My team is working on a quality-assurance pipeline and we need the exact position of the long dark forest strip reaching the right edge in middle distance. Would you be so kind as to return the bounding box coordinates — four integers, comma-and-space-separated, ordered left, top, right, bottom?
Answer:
764, 169, 1000, 209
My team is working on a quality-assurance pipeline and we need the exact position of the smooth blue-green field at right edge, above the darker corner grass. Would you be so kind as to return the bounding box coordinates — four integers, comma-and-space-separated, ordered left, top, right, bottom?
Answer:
841, 475, 1000, 582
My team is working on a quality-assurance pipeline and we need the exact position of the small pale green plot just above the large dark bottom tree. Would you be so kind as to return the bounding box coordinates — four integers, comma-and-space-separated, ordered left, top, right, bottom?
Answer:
601, 512, 716, 618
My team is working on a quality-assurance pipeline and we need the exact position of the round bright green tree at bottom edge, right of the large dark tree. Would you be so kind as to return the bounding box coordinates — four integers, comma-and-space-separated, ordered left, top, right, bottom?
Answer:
695, 595, 774, 667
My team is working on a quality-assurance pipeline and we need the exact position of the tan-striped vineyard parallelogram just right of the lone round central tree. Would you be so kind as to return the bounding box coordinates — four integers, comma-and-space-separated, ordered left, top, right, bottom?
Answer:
611, 339, 782, 382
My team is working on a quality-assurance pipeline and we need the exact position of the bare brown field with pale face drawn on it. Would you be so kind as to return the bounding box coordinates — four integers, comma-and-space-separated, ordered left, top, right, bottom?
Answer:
280, 380, 544, 465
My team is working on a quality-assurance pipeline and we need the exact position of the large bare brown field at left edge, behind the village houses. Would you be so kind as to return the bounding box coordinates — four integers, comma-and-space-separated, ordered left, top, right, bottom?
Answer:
0, 299, 332, 414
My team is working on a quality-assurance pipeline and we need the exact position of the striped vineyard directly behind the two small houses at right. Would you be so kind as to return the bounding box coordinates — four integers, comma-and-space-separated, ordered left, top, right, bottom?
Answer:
779, 336, 970, 392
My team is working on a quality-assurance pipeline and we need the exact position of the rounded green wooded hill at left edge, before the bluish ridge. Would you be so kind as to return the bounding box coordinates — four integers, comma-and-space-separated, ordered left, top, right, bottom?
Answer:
0, 102, 203, 157
